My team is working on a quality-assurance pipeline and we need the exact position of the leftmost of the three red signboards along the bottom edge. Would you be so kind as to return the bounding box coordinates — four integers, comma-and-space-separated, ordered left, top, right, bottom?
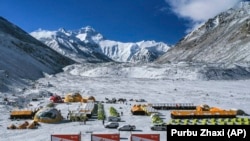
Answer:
51, 133, 81, 141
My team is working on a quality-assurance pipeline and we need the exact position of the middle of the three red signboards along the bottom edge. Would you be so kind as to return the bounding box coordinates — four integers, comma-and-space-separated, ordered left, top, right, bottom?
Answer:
91, 134, 120, 141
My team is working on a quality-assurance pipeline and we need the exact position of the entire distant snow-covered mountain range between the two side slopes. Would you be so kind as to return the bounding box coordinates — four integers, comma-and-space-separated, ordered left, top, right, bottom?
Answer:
30, 26, 169, 62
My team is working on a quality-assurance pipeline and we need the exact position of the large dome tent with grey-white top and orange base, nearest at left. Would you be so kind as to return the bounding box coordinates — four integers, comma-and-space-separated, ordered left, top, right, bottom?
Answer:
34, 107, 63, 123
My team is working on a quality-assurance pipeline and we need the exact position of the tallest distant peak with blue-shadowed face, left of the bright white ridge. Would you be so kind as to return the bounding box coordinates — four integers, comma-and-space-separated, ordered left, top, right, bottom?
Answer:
30, 26, 112, 62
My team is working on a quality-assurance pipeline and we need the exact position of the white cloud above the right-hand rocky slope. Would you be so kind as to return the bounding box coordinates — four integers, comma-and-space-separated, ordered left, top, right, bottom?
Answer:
165, 0, 241, 30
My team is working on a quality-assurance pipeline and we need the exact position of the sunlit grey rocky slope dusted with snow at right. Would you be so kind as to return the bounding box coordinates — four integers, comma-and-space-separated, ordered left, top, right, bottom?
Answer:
156, 2, 250, 65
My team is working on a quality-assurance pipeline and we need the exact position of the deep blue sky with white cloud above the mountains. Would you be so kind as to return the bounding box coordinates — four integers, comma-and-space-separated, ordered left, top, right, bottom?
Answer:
0, 0, 244, 45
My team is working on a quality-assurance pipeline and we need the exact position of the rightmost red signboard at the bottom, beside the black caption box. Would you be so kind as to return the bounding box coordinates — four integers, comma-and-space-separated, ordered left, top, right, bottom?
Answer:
130, 134, 160, 141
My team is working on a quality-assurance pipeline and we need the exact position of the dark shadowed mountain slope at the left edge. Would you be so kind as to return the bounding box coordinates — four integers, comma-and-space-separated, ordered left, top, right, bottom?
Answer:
0, 17, 75, 91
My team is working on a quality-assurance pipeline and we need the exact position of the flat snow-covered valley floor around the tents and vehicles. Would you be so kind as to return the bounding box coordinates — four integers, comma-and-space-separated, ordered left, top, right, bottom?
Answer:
0, 70, 250, 141
